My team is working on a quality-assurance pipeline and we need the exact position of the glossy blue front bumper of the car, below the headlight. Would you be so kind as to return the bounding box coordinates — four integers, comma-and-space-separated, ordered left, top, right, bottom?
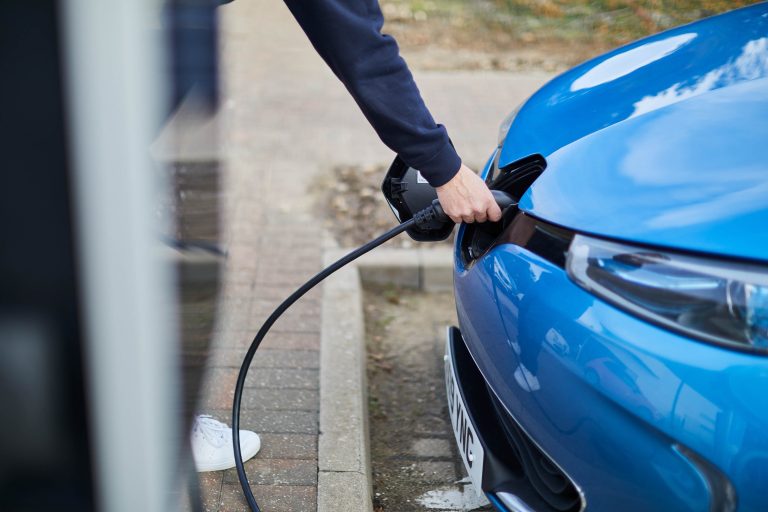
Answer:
454, 233, 768, 512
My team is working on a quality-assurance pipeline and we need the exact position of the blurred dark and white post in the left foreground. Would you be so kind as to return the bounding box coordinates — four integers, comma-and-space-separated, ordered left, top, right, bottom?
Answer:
0, 0, 222, 512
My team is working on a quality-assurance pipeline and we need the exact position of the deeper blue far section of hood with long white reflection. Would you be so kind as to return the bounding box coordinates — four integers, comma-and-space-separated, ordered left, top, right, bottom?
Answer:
499, 3, 768, 167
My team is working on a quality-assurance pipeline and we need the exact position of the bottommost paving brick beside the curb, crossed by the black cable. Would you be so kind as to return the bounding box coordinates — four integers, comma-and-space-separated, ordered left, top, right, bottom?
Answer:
219, 483, 317, 512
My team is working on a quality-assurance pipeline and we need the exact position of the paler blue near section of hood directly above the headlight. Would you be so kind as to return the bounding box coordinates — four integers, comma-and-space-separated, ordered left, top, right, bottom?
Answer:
520, 78, 768, 260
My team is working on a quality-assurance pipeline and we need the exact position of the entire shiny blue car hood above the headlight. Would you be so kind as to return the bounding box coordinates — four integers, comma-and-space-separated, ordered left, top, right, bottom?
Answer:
499, 4, 768, 260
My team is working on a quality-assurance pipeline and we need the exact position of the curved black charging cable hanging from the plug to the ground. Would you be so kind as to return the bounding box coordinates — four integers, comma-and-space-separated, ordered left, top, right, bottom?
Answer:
232, 217, 416, 512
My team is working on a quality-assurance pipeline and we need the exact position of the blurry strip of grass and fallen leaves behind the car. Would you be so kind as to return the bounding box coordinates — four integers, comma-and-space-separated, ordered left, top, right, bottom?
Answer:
382, 0, 758, 64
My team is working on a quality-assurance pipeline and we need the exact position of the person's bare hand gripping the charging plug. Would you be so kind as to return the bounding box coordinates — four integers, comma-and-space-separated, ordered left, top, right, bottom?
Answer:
437, 164, 501, 224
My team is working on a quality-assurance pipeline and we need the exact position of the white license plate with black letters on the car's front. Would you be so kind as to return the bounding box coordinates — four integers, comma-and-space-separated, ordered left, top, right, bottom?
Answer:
445, 331, 485, 496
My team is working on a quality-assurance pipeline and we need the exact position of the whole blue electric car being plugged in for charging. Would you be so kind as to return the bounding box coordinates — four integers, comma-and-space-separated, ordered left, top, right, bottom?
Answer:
446, 3, 768, 512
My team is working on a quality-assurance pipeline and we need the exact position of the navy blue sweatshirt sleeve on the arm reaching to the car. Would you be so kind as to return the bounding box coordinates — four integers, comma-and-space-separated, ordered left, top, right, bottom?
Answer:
285, 0, 461, 187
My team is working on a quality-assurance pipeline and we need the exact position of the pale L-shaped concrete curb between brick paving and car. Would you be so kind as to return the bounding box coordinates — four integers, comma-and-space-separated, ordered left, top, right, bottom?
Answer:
317, 241, 452, 512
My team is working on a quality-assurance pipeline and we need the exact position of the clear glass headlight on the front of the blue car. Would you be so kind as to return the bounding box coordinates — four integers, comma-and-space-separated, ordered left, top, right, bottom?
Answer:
566, 235, 768, 351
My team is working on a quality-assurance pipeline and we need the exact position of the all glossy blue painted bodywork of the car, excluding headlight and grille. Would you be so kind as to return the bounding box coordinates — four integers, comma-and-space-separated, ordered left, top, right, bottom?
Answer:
455, 4, 768, 512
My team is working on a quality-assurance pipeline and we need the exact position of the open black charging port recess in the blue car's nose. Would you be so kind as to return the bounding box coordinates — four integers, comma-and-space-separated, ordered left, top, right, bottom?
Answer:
460, 155, 546, 265
